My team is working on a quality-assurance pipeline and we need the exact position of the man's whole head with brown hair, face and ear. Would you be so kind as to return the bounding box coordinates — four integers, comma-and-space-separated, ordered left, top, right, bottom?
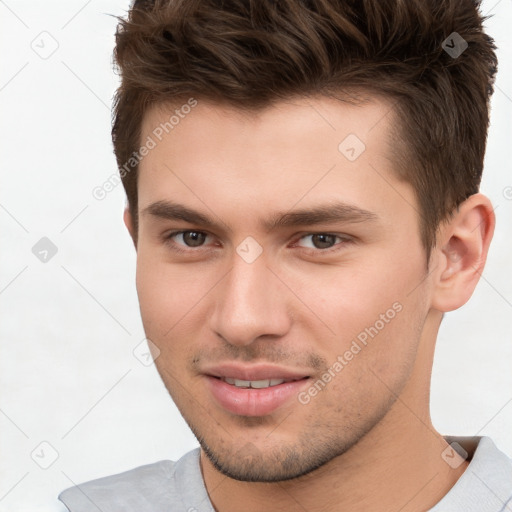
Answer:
112, 0, 496, 480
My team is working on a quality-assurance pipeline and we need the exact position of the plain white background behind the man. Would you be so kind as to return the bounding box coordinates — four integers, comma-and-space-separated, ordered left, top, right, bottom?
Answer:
0, 0, 512, 512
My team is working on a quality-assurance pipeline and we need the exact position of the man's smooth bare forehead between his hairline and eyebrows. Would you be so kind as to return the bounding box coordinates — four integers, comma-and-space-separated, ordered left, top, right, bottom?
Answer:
135, 97, 414, 232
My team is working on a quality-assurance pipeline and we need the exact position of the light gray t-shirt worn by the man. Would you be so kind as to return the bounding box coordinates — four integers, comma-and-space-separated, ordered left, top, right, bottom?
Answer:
59, 436, 512, 512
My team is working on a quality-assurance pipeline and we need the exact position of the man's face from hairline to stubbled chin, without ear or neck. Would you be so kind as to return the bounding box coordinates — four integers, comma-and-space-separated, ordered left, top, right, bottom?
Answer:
131, 98, 429, 481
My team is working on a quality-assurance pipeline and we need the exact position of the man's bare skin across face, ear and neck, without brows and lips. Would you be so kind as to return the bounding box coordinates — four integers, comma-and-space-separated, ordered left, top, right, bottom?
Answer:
125, 97, 494, 512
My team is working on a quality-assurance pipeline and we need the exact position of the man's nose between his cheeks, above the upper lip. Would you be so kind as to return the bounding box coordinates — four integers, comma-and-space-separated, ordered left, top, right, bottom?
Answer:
210, 254, 291, 346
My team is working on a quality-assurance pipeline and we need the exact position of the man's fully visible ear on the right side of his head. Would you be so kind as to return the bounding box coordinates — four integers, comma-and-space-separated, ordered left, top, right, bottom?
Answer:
432, 193, 496, 312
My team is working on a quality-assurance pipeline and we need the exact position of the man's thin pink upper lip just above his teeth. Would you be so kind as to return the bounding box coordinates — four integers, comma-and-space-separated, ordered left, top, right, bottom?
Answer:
202, 363, 309, 381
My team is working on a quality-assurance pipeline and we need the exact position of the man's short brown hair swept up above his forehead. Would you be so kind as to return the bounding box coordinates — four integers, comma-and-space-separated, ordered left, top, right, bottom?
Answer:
112, 0, 497, 261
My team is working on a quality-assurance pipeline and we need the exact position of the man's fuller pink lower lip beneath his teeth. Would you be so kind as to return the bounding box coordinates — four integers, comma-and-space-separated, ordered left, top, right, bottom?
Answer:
206, 375, 309, 416
